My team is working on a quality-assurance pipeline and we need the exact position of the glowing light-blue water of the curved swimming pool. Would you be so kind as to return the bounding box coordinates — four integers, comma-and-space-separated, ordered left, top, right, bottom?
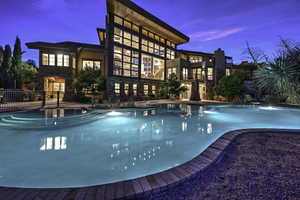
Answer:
0, 104, 300, 188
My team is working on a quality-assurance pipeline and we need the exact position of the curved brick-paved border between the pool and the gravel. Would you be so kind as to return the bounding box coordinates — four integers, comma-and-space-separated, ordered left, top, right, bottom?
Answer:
0, 129, 300, 200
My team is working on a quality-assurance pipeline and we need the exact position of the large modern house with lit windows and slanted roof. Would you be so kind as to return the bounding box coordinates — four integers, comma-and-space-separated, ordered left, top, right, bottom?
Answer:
26, 0, 232, 100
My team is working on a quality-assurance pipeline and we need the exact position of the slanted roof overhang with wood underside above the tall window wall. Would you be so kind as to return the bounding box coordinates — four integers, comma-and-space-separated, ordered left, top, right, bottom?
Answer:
107, 0, 190, 45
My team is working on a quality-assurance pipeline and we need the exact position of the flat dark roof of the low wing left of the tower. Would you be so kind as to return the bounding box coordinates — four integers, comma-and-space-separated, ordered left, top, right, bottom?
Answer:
26, 41, 104, 50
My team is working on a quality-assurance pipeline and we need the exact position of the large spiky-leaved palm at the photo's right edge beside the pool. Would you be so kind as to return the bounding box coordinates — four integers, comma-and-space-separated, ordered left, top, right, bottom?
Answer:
255, 40, 300, 103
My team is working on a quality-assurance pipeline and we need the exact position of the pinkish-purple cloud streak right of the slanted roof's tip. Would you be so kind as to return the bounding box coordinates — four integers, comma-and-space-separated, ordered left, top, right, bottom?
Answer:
190, 27, 246, 41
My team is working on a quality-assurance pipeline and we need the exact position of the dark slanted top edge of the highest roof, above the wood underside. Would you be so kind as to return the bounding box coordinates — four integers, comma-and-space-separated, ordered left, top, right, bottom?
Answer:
107, 0, 190, 42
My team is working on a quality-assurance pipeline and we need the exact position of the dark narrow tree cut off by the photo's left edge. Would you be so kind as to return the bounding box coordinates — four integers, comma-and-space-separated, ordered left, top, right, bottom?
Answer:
1, 45, 11, 88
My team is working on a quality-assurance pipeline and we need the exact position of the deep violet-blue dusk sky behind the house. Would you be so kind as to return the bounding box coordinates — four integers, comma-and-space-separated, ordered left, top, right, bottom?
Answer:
0, 0, 300, 63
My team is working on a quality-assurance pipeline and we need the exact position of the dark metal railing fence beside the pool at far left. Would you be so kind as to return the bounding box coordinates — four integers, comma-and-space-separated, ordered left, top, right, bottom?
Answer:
0, 90, 64, 112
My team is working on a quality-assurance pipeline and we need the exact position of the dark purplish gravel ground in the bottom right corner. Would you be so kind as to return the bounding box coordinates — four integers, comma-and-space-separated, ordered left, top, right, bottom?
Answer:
144, 133, 300, 200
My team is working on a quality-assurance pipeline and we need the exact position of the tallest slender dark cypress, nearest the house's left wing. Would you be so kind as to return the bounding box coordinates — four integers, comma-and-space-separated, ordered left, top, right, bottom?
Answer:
11, 36, 23, 89
